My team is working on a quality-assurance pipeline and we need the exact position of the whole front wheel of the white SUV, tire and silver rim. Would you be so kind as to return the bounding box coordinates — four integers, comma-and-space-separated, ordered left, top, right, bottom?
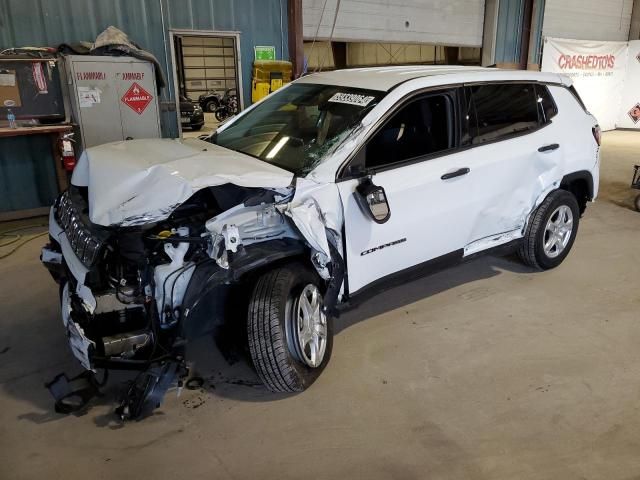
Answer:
247, 264, 333, 392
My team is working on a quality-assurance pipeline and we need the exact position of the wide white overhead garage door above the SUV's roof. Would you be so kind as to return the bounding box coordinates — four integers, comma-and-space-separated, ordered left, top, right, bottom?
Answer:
302, 0, 484, 47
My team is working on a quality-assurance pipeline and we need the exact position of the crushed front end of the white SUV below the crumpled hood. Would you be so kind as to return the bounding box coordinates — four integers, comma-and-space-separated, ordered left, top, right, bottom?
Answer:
42, 179, 344, 420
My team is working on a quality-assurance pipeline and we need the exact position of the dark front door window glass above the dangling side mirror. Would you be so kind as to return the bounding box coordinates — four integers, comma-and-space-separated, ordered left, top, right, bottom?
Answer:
365, 94, 453, 168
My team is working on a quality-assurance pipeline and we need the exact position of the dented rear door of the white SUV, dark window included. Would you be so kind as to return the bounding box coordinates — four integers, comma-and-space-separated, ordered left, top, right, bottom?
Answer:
460, 82, 562, 255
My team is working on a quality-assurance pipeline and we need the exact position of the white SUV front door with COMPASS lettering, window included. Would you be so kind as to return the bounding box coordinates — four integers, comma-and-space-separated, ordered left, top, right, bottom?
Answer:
338, 89, 477, 294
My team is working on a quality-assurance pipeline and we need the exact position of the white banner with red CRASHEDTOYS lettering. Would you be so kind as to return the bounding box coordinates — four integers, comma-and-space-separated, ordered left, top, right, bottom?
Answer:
541, 37, 628, 130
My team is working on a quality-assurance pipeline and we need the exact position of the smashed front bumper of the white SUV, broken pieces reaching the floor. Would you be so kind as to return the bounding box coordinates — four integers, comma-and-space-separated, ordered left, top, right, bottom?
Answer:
40, 207, 188, 419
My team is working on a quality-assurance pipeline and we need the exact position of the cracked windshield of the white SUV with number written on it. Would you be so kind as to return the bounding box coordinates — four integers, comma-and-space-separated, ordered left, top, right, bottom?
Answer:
212, 83, 384, 175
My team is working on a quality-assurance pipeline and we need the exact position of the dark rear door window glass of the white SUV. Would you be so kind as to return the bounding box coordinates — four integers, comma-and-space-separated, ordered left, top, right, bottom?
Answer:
463, 83, 538, 145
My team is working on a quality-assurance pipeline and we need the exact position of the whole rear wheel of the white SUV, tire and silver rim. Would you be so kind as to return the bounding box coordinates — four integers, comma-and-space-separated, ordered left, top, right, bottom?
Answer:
518, 190, 580, 270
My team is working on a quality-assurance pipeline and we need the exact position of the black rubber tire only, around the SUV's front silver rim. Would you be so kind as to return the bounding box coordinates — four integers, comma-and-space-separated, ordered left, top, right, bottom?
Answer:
247, 263, 333, 392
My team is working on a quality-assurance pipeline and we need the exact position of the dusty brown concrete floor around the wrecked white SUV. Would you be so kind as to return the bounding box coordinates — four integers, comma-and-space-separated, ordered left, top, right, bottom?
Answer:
0, 132, 640, 480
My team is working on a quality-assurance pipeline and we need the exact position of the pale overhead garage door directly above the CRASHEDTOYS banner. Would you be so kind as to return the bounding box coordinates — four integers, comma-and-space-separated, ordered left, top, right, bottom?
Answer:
542, 0, 633, 42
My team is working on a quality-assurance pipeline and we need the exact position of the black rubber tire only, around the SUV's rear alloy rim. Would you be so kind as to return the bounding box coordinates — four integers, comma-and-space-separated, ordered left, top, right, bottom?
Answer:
518, 190, 580, 270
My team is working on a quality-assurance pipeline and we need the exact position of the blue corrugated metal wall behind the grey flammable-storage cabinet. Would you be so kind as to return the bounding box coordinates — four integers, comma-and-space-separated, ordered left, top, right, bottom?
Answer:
0, 0, 289, 137
